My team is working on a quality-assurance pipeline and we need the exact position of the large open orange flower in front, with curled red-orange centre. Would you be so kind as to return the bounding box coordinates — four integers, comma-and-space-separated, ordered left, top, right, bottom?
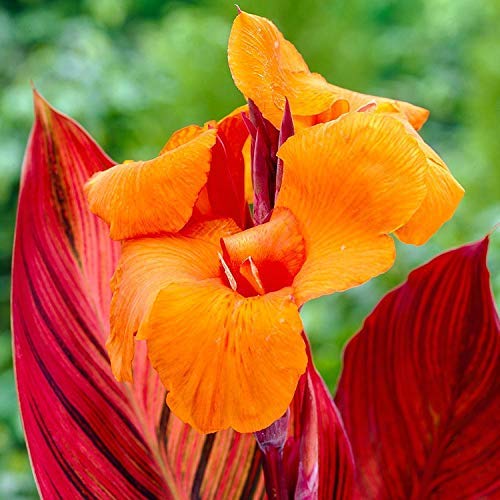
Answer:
88, 113, 428, 432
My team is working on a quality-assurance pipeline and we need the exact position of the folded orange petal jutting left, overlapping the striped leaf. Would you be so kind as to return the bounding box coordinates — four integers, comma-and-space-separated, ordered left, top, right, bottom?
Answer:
85, 130, 216, 240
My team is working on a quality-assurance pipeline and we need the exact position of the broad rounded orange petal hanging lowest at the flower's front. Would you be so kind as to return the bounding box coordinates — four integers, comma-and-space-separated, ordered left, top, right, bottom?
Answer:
141, 280, 307, 433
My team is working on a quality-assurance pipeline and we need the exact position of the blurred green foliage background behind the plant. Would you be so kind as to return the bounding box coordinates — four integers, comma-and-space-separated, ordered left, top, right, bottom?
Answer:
0, 0, 500, 499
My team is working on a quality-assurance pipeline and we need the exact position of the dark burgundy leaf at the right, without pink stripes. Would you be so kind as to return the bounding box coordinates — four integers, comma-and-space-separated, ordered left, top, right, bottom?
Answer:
336, 238, 500, 499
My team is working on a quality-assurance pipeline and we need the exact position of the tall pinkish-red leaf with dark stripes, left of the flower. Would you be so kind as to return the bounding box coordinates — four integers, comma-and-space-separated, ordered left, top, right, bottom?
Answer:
12, 92, 263, 498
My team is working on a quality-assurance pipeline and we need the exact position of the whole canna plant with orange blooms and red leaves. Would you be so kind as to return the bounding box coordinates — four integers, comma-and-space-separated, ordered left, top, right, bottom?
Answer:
12, 11, 499, 499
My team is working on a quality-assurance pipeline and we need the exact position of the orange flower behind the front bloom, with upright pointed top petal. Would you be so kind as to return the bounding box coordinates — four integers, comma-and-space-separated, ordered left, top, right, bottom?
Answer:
228, 12, 464, 245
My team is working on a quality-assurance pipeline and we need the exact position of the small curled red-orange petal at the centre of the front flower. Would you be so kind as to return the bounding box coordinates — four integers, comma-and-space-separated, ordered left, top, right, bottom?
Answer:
221, 208, 305, 293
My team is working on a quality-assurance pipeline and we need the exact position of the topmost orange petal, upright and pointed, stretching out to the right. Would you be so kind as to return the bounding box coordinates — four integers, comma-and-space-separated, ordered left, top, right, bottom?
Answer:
228, 12, 429, 129
